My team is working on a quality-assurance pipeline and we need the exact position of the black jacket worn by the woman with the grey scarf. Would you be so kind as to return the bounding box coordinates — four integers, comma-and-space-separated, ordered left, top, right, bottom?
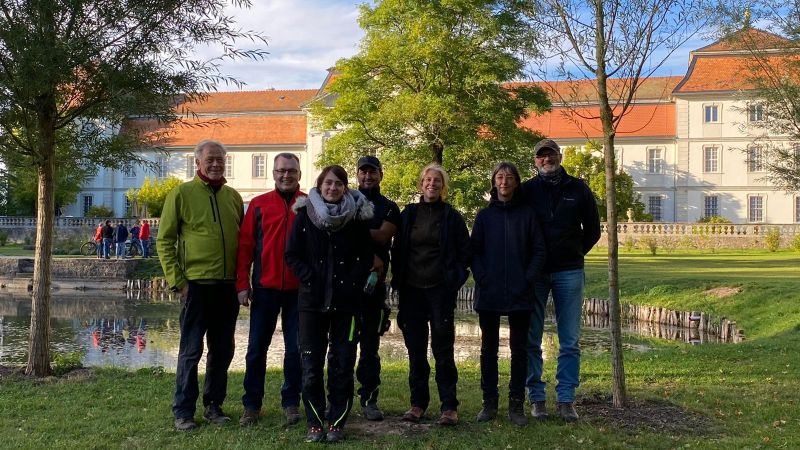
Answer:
284, 200, 374, 312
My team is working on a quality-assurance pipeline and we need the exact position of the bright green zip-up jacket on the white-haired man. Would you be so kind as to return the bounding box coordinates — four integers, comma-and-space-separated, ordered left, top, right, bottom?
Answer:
156, 176, 243, 289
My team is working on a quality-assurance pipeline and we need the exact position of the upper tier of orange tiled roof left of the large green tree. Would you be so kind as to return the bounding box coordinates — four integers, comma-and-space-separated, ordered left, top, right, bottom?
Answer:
178, 89, 317, 114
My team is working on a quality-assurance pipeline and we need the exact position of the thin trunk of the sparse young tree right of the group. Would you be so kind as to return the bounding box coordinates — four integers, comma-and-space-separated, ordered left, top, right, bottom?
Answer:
594, 0, 628, 408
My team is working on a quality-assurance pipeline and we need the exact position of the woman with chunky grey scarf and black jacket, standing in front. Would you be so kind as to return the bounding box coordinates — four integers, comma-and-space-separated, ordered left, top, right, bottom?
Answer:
285, 166, 375, 442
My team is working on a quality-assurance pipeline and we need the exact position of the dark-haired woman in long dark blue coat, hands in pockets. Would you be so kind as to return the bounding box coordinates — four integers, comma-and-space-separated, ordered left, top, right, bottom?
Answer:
472, 162, 545, 426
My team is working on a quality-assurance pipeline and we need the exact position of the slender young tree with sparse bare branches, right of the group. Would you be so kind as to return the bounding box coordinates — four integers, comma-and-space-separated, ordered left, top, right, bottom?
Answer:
530, 0, 709, 407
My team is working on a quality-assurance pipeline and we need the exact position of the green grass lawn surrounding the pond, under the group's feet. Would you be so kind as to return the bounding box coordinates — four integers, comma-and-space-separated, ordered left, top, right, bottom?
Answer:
0, 252, 800, 449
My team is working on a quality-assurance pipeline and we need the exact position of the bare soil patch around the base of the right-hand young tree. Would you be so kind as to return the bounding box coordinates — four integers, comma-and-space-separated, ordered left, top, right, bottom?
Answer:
575, 395, 713, 435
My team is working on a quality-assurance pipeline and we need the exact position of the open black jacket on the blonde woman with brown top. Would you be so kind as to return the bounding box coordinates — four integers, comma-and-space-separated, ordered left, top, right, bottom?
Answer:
392, 203, 472, 292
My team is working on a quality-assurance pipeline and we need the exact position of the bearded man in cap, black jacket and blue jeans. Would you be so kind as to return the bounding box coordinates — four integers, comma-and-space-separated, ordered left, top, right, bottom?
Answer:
522, 139, 600, 422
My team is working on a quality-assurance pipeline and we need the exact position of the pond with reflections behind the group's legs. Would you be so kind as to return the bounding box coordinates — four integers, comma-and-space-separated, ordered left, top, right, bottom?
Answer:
0, 292, 714, 370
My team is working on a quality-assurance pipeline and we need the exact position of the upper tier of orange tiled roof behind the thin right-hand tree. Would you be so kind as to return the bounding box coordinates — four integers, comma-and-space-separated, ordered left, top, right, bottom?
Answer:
506, 77, 683, 104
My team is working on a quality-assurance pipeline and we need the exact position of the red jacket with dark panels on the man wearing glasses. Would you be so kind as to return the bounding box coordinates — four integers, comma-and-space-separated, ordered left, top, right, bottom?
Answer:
236, 190, 306, 291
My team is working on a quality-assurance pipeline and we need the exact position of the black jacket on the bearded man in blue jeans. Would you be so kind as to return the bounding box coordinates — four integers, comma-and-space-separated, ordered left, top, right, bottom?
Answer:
522, 168, 600, 273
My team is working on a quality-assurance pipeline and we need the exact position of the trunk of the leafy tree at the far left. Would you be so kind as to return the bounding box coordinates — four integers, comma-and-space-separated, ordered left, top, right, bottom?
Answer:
25, 100, 55, 377
